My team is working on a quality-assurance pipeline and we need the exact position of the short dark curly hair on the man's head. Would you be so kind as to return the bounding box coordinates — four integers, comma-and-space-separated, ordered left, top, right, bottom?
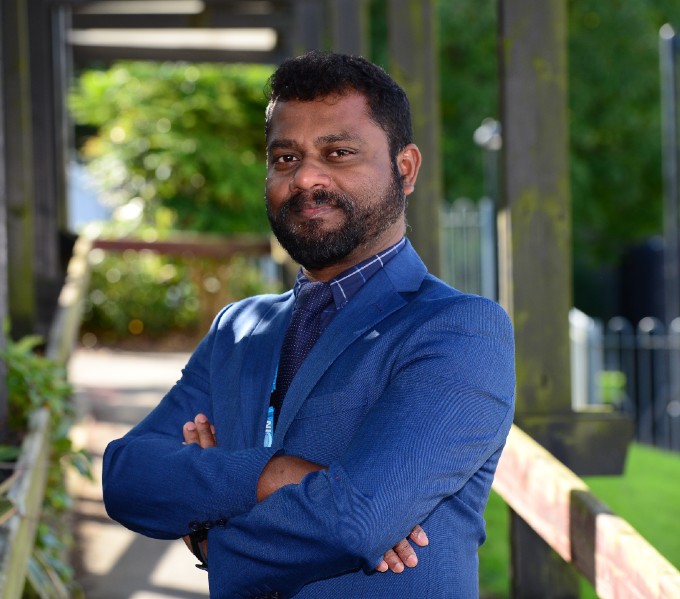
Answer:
265, 50, 413, 158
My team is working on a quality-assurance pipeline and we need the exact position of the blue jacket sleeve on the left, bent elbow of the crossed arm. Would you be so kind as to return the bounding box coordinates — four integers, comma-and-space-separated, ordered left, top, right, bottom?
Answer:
102, 308, 273, 539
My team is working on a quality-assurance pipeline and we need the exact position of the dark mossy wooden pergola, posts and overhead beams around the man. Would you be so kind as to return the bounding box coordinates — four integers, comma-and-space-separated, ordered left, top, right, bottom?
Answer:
0, 0, 630, 597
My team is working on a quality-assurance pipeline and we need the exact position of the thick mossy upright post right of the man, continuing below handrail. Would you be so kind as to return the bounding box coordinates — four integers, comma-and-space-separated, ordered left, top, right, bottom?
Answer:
499, 0, 579, 599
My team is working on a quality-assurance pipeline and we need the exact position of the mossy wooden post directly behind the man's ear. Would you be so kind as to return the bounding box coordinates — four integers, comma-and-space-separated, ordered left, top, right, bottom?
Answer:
388, 0, 443, 275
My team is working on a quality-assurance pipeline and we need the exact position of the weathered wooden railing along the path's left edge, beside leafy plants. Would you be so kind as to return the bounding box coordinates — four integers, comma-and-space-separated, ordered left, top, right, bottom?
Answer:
0, 238, 91, 599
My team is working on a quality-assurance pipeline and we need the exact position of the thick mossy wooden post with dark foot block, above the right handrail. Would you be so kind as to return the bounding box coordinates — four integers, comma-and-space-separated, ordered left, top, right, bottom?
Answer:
498, 0, 632, 475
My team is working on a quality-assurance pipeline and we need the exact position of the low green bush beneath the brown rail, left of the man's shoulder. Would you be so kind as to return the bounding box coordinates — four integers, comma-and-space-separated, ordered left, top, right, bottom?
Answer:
82, 250, 280, 345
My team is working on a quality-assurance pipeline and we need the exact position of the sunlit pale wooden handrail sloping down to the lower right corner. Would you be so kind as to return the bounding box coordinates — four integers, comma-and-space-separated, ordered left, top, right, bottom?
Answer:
493, 426, 680, 599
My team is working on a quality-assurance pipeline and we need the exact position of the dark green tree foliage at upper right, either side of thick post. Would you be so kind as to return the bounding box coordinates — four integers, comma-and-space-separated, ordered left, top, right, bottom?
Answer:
438, 0, 680, 268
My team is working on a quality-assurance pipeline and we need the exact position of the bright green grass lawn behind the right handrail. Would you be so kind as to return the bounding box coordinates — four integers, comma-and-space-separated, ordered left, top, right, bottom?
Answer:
479, 443, 680, 599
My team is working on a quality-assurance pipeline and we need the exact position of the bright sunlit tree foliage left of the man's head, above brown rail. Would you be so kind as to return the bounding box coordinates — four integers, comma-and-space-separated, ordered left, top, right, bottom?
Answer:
70, 62, 271, 232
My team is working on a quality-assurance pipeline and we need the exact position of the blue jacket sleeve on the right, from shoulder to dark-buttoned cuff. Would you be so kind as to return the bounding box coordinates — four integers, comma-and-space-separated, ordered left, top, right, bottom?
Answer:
208, 298, 515, 597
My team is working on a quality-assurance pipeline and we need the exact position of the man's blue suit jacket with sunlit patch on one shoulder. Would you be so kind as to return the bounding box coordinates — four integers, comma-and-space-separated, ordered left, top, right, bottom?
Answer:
104, 244, 515, 599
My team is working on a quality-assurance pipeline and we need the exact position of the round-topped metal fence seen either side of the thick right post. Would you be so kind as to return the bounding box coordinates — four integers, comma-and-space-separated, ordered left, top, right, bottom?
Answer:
441, 199, 680, 451
